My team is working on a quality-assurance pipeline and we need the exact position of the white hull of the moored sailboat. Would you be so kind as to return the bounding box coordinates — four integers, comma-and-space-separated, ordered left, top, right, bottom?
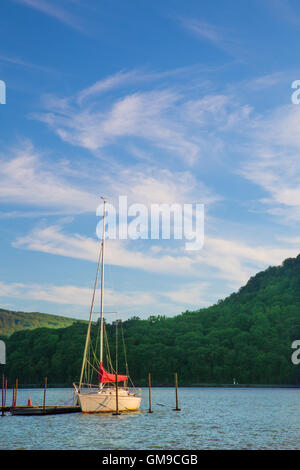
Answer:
77, 389, 141, 413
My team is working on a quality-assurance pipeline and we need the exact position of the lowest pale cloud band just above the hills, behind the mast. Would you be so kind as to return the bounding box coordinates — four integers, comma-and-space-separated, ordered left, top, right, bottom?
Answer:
0, 281, 216, 322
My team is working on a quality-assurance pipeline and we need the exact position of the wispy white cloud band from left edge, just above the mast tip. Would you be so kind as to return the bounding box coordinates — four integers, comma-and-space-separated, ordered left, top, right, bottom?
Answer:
0, 141, 221, 218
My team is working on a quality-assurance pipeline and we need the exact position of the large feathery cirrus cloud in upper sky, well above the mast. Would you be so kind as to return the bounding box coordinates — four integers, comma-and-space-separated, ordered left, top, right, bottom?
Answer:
32, 70, 250, 166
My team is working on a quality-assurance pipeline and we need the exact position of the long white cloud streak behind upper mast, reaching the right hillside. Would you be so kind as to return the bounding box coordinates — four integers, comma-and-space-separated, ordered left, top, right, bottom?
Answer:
13, 225, 298, 289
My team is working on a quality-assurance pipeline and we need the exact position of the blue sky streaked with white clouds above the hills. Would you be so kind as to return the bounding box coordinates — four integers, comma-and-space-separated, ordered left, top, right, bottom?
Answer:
0, 0, 300, 319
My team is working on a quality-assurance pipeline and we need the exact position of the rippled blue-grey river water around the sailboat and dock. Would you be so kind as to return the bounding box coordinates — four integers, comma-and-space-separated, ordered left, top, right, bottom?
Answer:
0, 388, 300, 450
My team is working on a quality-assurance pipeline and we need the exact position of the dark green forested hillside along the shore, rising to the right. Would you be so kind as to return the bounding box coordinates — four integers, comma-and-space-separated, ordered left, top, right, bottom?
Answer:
0, 255, 300, 387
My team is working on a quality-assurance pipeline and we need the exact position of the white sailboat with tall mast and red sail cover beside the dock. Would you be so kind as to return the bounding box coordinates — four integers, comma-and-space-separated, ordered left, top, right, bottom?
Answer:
73, 200, 141, 413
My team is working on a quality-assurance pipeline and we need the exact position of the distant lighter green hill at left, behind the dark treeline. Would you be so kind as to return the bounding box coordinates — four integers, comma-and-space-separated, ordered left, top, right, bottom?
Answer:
0, 309, 82, 336
